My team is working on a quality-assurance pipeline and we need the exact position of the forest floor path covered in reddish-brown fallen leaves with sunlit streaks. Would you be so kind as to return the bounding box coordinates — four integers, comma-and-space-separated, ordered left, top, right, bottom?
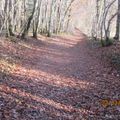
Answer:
0, 32, 120, 120
